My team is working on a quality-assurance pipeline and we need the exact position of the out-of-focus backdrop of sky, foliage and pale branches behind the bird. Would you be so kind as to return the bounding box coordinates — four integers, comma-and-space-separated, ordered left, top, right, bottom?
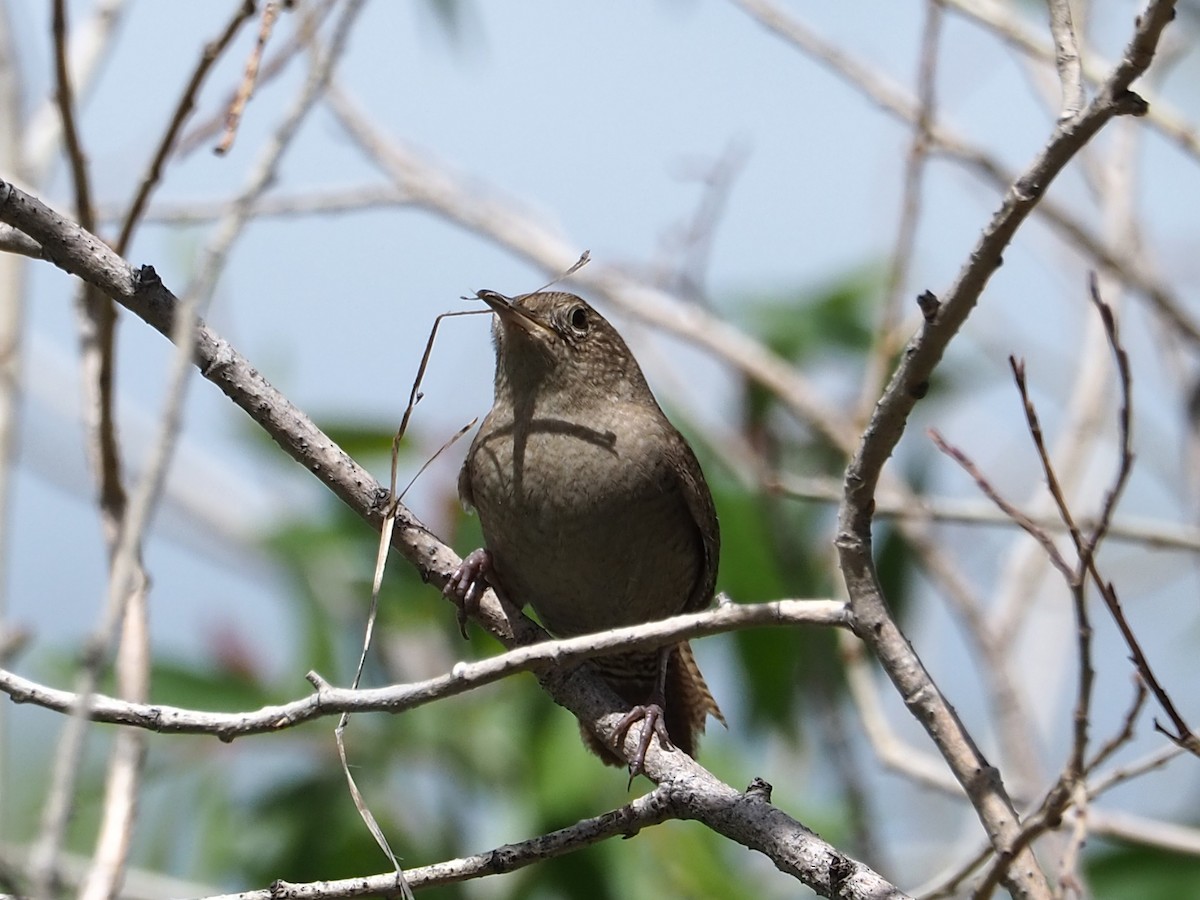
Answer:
0, 0, 1200, 898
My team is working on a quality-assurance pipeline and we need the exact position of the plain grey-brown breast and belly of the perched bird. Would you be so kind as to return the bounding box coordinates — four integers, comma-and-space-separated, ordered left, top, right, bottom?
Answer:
467, 405, 703, 635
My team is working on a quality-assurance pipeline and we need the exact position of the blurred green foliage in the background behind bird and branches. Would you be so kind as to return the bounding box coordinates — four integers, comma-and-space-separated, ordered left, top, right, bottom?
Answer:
14, 270, 1185, 900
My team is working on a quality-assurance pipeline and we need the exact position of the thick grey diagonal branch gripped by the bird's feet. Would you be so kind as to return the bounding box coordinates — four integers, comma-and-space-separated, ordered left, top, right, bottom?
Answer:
0, 180, 905, 900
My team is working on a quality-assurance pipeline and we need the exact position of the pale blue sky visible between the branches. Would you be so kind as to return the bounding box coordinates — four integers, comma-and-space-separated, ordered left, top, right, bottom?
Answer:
8, 0, 1200, 883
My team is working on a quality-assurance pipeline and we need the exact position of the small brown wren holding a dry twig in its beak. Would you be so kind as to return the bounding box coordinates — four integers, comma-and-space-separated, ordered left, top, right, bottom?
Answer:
446, 290, 725, 776
